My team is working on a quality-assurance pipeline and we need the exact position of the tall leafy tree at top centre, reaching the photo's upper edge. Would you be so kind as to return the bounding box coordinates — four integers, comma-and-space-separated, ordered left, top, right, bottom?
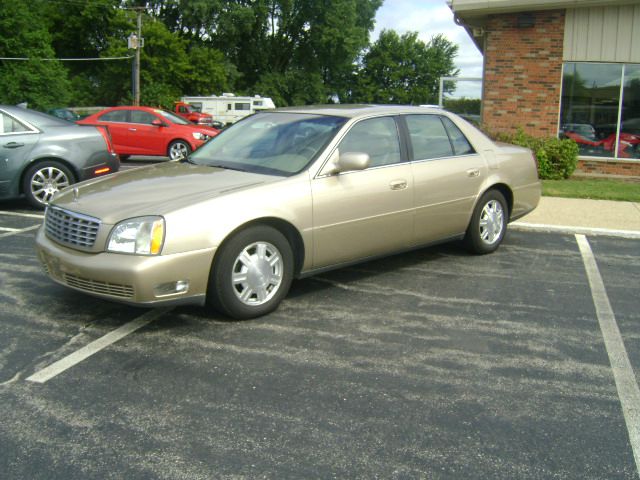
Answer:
147, 0, 382, 105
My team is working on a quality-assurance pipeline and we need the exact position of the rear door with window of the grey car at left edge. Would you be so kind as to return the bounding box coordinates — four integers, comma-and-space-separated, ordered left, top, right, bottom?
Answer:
0, 110, 40, 197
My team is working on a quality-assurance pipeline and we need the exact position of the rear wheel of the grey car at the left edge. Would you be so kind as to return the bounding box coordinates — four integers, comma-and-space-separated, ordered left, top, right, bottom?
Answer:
22, 160, 76, 208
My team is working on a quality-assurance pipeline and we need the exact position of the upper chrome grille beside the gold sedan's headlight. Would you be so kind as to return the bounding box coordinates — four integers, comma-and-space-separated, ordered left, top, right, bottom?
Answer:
44, 207, 100, 248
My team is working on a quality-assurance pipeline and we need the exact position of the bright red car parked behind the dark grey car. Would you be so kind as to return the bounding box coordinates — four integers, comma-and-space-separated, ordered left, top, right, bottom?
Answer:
77, 107, 220, 160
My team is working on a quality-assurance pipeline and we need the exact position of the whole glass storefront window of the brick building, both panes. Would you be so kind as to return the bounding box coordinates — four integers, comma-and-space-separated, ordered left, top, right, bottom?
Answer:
559, 63, 640, 158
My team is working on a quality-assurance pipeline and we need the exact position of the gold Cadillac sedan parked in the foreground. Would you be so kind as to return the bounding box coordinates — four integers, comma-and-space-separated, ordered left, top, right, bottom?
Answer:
37, 105, 540, 319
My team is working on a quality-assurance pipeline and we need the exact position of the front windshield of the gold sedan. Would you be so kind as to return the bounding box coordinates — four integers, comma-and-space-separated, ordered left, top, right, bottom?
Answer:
189, 112, 347, 176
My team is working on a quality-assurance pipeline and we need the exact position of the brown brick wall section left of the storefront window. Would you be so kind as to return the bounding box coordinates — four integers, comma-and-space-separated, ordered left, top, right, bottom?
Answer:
482, 10, 565, 136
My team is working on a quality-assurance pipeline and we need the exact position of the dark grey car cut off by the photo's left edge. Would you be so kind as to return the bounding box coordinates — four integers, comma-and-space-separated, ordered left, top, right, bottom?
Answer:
0, 105, 120, 208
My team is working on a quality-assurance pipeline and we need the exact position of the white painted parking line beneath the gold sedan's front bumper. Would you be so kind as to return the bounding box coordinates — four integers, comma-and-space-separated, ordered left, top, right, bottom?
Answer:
27, 308, 172, 383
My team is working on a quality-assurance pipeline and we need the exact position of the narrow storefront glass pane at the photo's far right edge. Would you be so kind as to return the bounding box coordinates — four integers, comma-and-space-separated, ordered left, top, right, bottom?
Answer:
618, 65, 640, 158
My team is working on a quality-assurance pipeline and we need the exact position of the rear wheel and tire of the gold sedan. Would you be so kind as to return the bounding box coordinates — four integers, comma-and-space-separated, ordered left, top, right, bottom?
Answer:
464, 190, 509, 255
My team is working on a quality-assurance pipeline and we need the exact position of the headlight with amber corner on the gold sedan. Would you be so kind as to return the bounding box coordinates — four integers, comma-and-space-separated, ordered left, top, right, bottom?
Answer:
107, 217, 164, 255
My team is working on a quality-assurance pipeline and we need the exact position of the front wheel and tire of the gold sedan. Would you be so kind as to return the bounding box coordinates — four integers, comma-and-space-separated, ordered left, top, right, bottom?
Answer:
207, 225, 293, 320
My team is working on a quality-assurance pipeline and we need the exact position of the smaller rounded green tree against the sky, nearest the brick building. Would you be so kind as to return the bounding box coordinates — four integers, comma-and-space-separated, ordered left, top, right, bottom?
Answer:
351, 30, 459, 105
